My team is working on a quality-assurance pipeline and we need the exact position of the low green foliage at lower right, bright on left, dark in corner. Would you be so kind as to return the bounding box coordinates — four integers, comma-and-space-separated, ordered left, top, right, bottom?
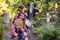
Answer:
32, 24, 59, 40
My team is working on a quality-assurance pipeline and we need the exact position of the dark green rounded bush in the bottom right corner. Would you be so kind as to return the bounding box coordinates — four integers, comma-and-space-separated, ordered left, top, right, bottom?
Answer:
43, 30, 58, 40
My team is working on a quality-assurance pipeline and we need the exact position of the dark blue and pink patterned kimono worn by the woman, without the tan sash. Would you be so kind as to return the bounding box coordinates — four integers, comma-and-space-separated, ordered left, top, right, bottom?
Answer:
10, 13, 29, 40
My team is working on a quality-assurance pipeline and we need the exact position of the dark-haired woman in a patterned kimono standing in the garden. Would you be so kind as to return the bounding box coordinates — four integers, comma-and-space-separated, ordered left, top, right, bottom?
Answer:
10, 6, 30, 40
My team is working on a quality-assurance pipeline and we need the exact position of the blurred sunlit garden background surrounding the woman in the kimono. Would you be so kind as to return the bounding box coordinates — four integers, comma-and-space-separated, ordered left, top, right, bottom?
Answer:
0, 0, 60, 40
